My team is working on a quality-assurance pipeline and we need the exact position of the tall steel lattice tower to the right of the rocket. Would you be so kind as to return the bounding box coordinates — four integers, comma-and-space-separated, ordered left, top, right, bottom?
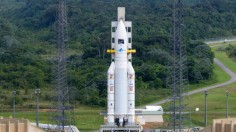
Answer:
167, 0, 191, 132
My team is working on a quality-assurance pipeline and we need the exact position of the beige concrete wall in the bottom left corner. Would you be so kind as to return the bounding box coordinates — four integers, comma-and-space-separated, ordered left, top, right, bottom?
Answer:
0, 119, 44, 132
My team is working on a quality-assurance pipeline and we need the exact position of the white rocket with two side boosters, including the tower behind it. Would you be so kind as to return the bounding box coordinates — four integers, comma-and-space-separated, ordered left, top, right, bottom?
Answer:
107, 7, 136, 126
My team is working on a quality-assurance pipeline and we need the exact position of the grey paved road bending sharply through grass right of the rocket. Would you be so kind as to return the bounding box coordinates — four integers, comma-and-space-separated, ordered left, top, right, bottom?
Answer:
139, 41, 236, 108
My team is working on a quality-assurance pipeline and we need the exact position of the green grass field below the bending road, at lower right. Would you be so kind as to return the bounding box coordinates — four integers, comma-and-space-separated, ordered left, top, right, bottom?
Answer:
190, 83, 236, 126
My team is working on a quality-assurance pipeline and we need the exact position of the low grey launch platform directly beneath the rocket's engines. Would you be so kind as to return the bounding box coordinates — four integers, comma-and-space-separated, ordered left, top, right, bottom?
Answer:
100, 124, 142, 132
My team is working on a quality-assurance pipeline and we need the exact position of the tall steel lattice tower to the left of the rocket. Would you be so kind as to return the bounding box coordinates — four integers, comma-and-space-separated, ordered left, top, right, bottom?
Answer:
50, 0, 73, 132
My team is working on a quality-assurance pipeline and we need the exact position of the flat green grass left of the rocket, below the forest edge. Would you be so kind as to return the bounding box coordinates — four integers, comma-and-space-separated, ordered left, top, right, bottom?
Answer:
0, 106, 104, 132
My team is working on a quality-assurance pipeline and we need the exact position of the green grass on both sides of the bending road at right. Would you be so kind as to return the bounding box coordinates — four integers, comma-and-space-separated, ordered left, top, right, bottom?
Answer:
179, 42, 236, 126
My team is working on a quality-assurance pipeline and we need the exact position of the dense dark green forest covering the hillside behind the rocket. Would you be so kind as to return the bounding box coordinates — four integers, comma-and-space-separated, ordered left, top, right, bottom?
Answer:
0, 0, 236, 106
